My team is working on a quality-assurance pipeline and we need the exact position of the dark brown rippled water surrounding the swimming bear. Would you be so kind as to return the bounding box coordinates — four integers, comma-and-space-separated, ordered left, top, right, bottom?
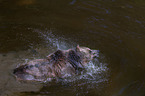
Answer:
0, 0, 145, 96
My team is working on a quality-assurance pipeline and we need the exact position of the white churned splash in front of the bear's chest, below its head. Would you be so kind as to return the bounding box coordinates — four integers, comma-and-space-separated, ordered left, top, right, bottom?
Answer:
64, 61, 108, 83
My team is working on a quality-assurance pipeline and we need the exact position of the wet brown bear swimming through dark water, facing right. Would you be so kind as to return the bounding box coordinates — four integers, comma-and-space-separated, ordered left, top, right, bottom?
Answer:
13, 45, 98, 81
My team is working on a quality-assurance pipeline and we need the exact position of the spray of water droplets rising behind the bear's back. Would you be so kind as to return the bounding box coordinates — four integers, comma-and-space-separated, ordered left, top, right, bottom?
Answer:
34, 29, 76, 50
